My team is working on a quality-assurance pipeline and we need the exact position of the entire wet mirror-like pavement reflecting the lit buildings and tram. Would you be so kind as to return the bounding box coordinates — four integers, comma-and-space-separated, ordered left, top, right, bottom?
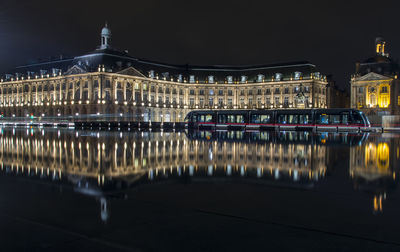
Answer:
0, 128, 400, 251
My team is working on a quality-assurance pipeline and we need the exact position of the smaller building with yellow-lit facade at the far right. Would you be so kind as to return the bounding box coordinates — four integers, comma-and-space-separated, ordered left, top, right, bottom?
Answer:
350, 38, 400, 115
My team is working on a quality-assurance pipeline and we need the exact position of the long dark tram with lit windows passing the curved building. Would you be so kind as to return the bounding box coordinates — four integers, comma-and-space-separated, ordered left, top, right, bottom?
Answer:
185, 109, 371, 131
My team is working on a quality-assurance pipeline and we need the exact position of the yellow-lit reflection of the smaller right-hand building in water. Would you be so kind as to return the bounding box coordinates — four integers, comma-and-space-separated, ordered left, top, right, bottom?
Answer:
350, 134, 400, 213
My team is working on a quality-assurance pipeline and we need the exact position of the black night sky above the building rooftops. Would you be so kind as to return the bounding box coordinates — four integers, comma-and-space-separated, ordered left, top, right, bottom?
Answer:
0, 0, 400, 87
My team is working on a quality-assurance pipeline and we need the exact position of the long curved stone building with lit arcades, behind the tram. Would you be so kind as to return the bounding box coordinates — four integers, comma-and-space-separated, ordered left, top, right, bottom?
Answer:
0, 25, 327, 122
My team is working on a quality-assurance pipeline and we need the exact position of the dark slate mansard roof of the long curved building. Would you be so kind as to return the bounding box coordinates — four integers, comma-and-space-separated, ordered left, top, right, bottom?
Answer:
7, 45, 324, 82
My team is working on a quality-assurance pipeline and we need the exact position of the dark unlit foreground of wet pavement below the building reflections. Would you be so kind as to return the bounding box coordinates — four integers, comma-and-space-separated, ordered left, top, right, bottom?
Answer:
0, 169, 400, 251
